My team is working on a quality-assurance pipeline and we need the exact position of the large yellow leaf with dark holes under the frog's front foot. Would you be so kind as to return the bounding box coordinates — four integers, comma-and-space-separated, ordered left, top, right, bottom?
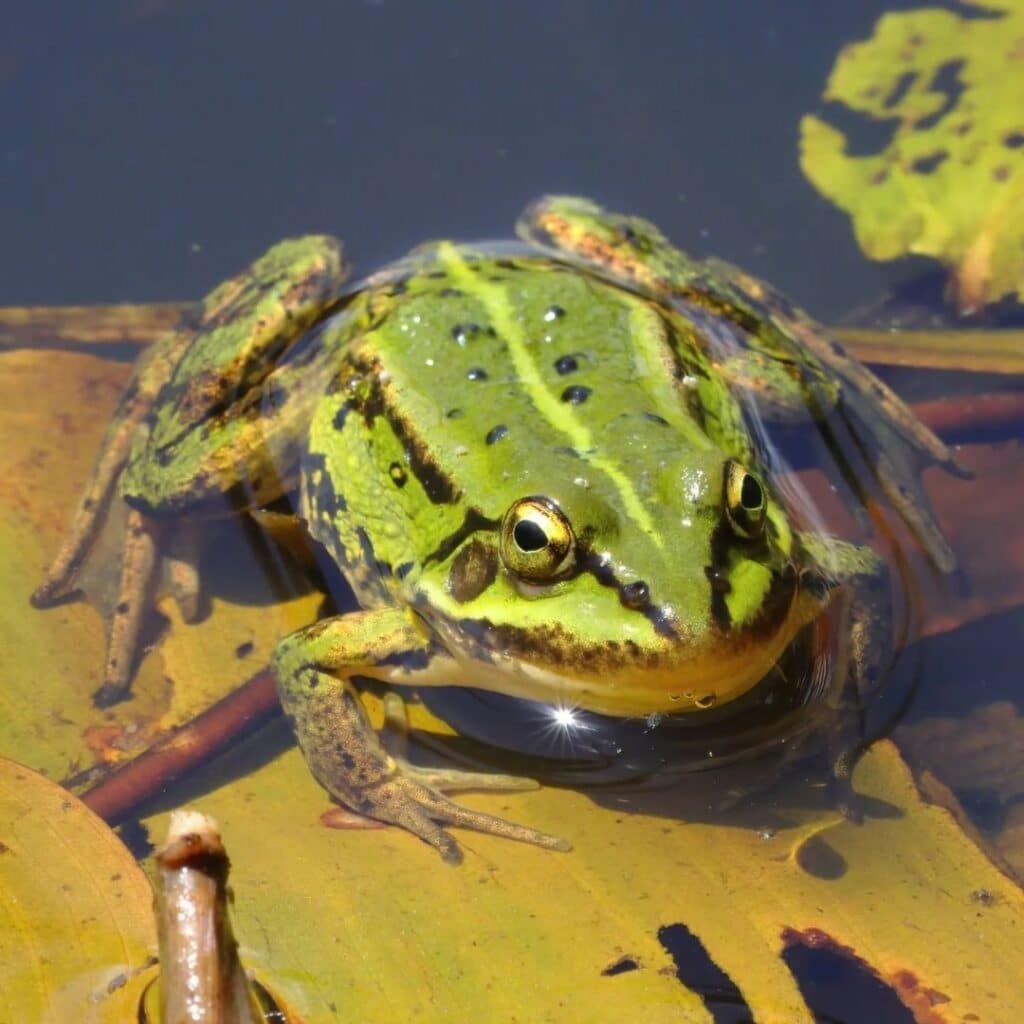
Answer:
138, 742, 1024, 1024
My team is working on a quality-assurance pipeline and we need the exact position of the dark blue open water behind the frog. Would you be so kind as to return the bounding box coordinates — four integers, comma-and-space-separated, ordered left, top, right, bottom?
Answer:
6, 0, 937, 317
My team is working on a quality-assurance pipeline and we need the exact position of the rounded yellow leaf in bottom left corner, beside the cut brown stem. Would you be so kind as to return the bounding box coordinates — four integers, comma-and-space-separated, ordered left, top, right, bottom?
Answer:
0, 759, 157, 1024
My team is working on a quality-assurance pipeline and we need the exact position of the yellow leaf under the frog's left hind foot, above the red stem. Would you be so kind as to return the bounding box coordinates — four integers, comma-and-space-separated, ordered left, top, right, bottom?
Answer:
0, 349, 319, 778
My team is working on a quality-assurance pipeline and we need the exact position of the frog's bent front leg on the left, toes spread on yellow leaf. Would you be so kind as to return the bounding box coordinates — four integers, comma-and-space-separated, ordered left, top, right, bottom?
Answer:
273, 608, 568, 863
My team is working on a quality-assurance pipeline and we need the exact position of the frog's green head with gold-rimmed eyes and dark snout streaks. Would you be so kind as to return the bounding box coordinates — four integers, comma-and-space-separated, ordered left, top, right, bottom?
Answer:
421, 446, 821, 715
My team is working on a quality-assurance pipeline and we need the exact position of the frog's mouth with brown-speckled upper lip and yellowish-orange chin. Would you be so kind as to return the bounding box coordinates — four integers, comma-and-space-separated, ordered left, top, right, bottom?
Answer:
415, 567, 821, 717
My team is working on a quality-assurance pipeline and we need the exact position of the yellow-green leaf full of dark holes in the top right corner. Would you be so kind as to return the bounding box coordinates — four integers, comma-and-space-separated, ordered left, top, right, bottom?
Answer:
800, 0, 1024, 312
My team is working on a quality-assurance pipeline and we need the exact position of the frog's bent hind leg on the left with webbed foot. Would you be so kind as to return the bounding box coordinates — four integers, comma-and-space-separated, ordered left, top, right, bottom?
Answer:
32, 237, 345, 706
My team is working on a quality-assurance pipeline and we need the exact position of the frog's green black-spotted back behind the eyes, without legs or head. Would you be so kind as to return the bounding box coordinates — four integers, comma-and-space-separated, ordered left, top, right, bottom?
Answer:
301, 244, 740, 589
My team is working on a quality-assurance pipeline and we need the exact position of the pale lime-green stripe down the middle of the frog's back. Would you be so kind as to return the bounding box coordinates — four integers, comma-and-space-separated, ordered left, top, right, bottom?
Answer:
437, 242, 664, 549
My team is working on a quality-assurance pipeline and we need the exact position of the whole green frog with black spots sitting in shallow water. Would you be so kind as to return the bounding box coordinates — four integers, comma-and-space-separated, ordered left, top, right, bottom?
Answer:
28, 196, 966, 863
